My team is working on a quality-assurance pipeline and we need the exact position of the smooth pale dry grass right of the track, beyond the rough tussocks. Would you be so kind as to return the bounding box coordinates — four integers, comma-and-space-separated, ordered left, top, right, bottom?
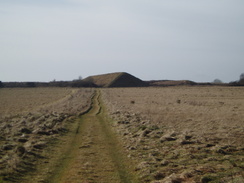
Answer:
104, 87, 244, 145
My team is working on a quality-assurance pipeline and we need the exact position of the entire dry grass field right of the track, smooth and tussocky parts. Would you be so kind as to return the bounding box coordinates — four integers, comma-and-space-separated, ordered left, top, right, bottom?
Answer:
102, 87, 244, 182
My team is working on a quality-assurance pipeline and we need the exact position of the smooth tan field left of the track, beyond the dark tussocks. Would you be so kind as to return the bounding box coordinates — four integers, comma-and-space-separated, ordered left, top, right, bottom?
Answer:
0, 88, 93, 118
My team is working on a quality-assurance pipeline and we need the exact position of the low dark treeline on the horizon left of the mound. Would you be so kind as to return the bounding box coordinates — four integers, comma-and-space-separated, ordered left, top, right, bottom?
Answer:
0, 80, 97, 88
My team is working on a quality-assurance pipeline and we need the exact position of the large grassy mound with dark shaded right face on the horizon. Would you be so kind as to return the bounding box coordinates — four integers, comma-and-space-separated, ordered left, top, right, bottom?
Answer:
84, 72, 148, 87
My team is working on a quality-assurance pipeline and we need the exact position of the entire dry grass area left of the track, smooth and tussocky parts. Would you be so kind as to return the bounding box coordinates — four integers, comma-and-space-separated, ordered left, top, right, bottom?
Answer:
0, 88, 93, 182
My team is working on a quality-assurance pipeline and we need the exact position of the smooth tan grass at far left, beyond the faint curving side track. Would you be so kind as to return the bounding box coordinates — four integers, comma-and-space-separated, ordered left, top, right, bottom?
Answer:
0, 88, 72, 116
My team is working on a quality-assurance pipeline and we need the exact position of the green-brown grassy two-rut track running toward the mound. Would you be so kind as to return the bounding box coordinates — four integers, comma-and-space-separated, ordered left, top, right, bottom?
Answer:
25, 91, 137, 183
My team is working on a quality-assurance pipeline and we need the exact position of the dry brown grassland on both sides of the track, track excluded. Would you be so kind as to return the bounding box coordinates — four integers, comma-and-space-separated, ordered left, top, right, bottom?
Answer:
0, 86, 244, 183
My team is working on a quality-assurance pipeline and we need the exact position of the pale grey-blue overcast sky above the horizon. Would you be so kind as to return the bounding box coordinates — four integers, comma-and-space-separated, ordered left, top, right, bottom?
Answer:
0, 0, 244, 82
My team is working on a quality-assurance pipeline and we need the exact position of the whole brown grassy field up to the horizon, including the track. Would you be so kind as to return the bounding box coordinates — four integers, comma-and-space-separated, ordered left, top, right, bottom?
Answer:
0, 86, 244, 183
